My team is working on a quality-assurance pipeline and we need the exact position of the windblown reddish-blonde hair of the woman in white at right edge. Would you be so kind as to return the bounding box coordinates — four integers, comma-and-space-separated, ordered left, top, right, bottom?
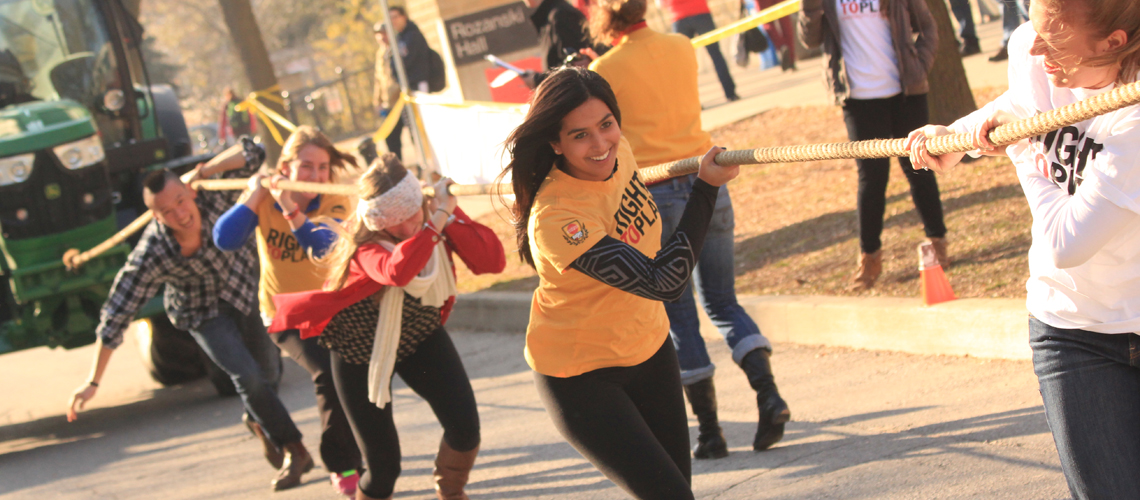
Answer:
1044, 0, 1140, 84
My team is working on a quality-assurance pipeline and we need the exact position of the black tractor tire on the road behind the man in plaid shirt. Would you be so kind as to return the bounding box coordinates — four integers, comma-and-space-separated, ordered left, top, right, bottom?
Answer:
135, 314, 206, 386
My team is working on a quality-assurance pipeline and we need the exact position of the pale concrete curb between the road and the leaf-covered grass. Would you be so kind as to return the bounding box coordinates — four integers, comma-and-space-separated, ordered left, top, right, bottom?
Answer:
448, 292, 1031, 360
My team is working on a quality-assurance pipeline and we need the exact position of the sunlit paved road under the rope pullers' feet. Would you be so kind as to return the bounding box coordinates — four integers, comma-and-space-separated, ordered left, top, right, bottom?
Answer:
0, 323, 1068, 500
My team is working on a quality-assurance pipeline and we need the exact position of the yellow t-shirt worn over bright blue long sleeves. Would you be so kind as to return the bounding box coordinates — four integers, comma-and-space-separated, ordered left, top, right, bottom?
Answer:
255, 195, 355, 318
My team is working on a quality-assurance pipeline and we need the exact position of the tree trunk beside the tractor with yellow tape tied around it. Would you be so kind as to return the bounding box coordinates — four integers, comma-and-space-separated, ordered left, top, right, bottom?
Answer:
218, 0, 288, 166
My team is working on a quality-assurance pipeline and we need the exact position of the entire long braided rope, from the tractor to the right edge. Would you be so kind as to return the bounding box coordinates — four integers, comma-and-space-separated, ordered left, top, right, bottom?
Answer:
64, 82, 1140, 269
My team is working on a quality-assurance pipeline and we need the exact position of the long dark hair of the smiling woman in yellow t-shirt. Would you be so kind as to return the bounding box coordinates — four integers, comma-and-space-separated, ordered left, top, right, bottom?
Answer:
496, 67, 621, 268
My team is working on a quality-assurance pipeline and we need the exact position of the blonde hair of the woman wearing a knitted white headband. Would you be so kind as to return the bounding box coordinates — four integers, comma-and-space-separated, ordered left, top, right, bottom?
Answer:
315, 153, 428, 292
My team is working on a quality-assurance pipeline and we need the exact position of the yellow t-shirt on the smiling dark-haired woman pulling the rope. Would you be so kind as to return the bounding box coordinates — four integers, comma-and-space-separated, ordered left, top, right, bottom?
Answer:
526, 139, 669, 377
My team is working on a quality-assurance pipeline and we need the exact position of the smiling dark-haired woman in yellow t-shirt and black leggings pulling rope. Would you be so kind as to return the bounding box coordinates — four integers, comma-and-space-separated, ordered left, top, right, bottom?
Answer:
500, 67, 739, 500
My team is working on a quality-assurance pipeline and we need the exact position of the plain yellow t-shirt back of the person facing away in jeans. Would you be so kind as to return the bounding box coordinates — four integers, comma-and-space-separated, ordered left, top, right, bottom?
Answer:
589, 27, 713, 169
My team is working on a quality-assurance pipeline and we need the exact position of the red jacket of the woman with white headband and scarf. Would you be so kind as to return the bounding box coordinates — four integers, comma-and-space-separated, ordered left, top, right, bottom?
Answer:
269, 207, 506, 338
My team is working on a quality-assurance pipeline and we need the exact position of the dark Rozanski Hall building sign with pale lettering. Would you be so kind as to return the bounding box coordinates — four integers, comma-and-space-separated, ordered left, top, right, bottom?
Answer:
443, 2, 538, 66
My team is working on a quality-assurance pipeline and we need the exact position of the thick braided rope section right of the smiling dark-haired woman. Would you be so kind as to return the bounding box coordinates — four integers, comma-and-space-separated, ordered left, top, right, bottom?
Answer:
638, 82, 1140, 183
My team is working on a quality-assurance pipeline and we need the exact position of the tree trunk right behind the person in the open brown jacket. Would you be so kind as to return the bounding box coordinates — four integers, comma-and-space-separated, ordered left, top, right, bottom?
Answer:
927, 0, 978, 125
